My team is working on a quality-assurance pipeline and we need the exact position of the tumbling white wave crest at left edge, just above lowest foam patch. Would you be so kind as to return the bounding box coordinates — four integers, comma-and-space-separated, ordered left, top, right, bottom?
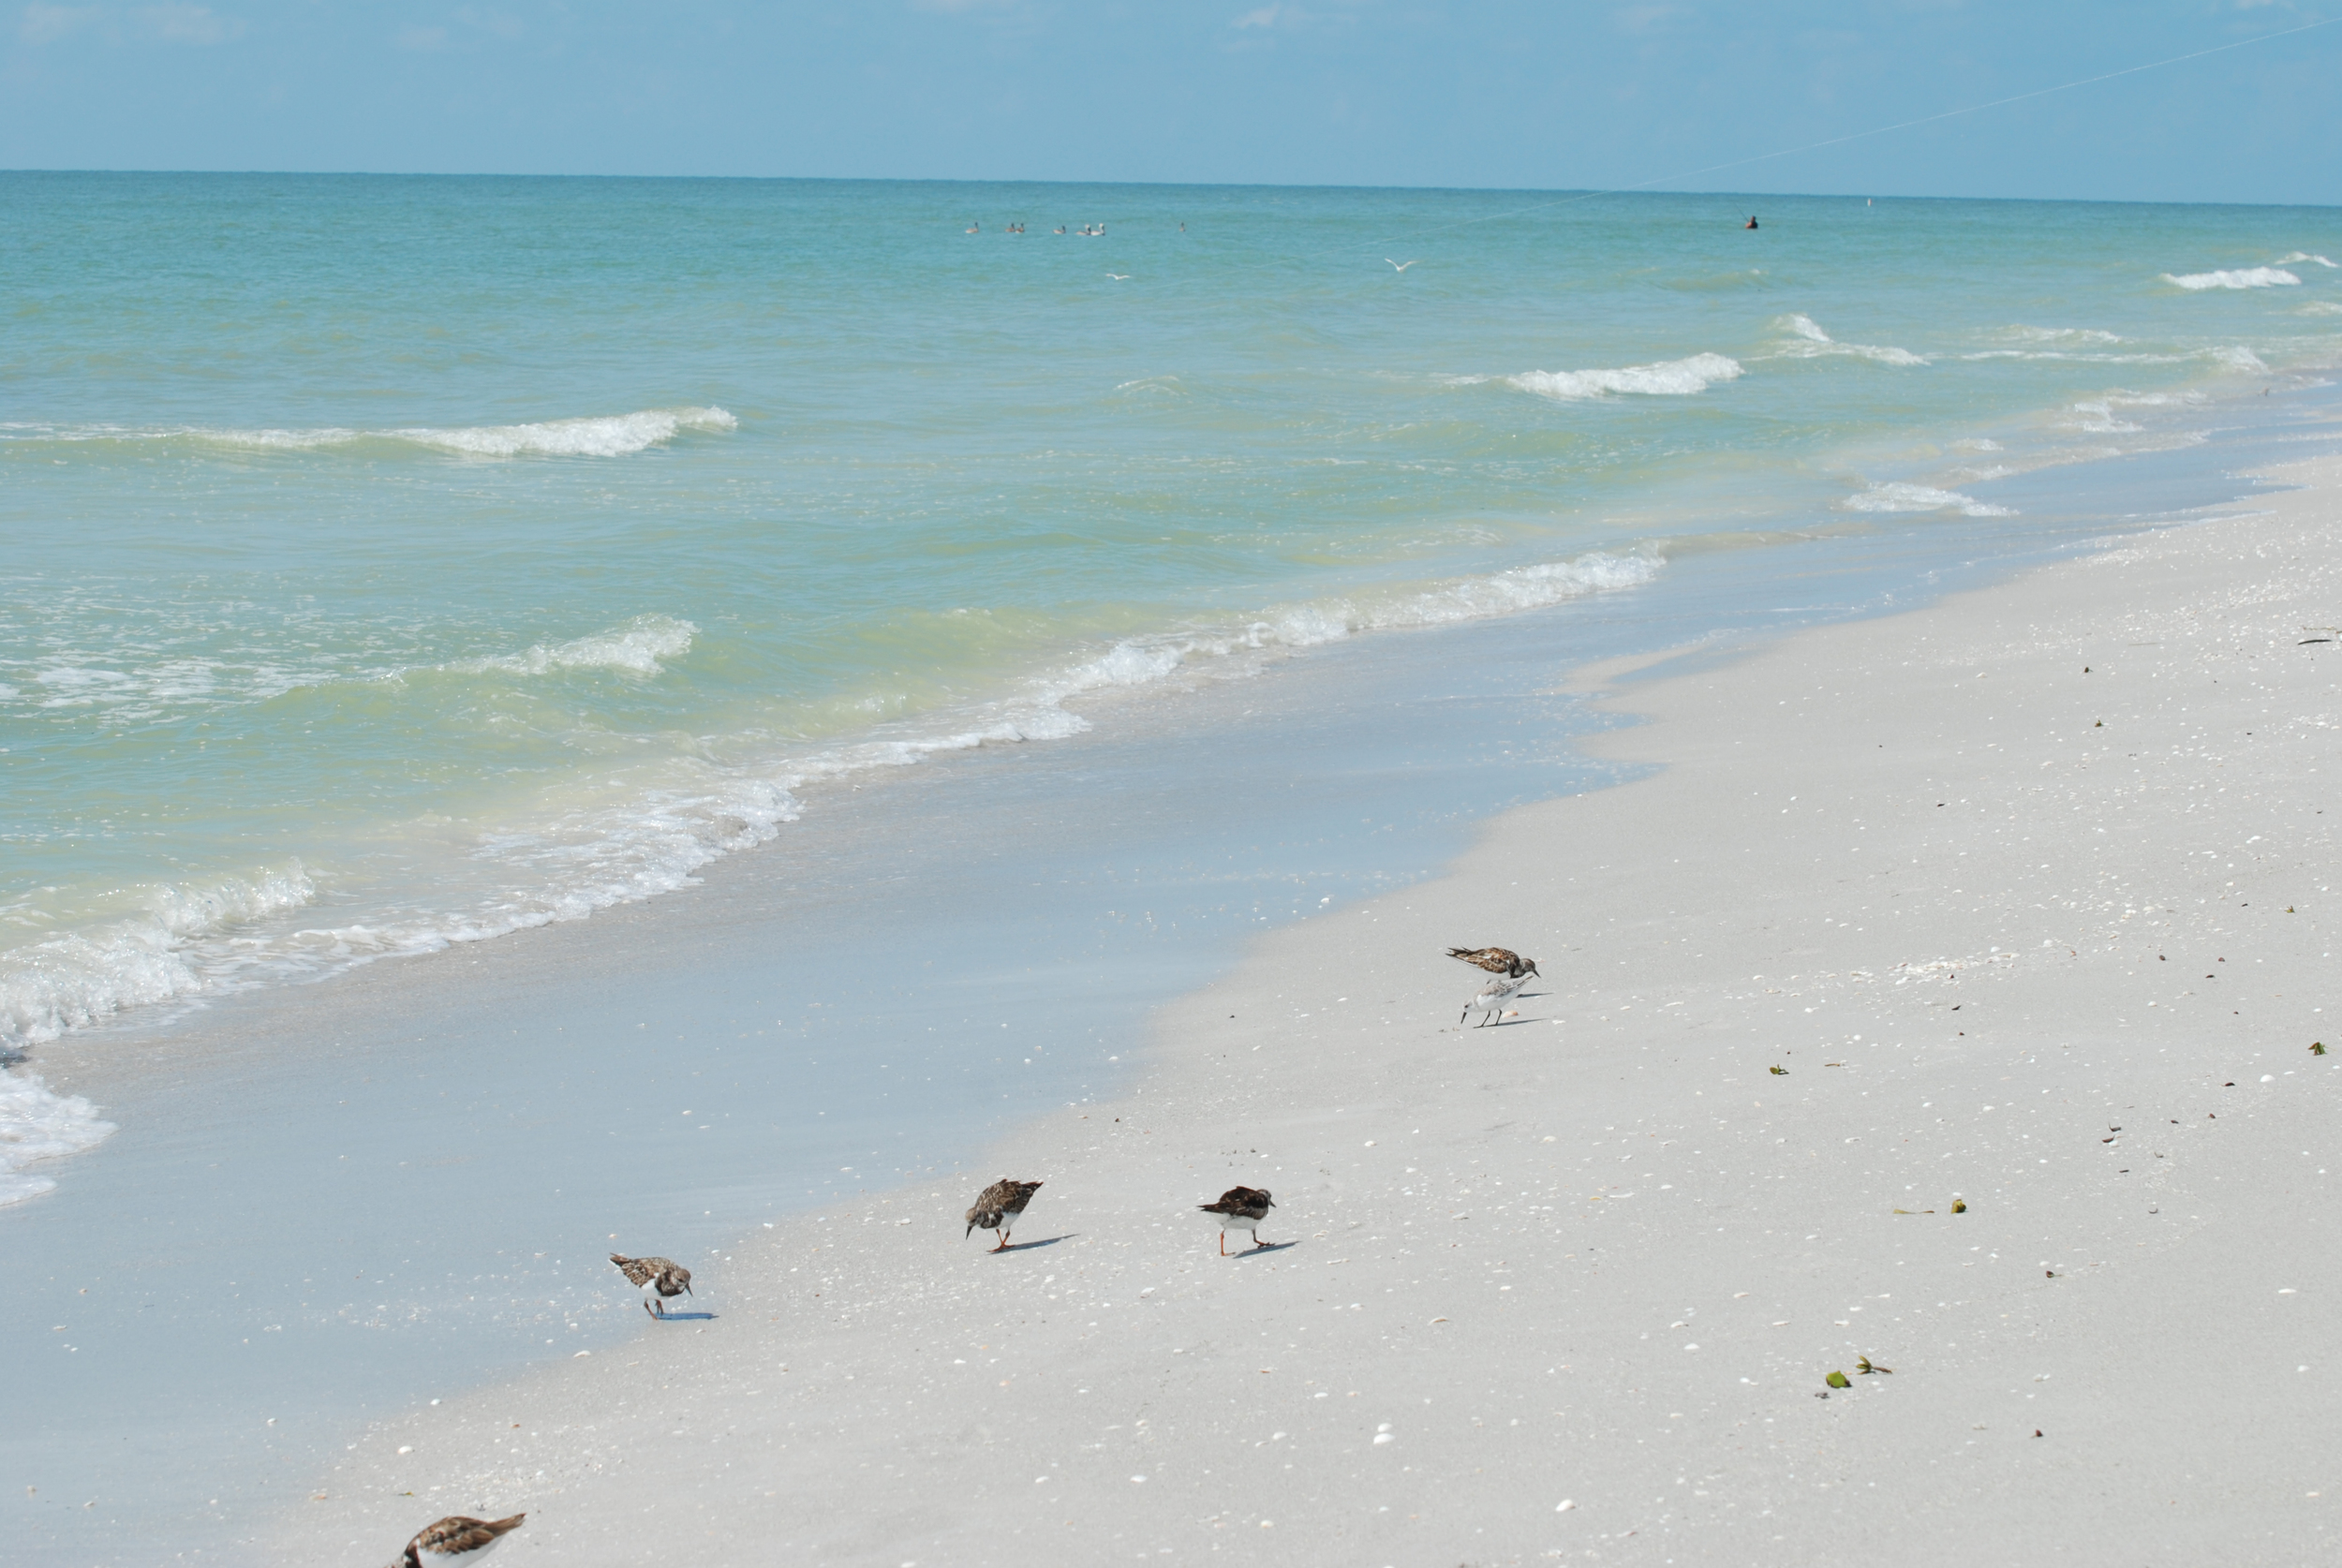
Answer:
0, 861, 317, 1046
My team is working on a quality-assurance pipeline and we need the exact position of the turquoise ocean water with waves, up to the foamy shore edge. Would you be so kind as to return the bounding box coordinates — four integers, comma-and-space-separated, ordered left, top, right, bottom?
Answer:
0, 173, 2342, 1203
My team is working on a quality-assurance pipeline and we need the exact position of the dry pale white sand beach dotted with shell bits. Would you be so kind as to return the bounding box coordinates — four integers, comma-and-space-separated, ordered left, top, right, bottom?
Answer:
262, 459, 2342, 1566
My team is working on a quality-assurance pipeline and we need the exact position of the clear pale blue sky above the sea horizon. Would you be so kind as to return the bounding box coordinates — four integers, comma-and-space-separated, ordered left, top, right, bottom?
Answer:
0, 0, 2342, 206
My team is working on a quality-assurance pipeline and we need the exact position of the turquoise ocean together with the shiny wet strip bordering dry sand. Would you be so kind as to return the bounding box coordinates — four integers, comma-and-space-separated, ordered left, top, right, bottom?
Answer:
0, 173, 2342, 1563
